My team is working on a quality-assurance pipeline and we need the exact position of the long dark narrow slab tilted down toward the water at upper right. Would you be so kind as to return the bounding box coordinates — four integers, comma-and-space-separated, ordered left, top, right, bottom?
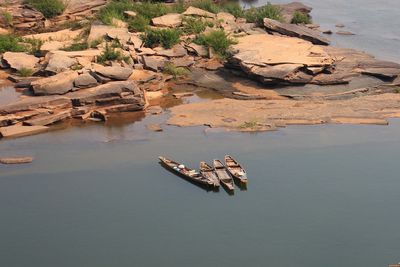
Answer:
264, 18, 330, 45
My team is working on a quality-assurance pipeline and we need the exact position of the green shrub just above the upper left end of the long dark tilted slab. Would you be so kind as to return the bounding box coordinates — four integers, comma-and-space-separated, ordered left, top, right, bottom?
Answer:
244, 3, 282, 25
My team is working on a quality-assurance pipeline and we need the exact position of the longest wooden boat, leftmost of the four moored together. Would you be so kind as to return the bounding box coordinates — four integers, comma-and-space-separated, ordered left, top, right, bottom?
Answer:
158, 157, 214, 186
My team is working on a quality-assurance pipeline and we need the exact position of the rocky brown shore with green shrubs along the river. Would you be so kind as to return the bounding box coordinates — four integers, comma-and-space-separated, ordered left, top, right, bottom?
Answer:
0, 0, 400, 138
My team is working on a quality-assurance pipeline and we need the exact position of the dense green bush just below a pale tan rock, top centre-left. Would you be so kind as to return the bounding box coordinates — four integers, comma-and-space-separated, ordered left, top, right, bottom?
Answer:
141, 29, 181, 49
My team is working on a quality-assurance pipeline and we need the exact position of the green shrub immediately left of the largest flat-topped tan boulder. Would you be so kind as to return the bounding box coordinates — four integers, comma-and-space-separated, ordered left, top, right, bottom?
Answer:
194, 30, 237, 58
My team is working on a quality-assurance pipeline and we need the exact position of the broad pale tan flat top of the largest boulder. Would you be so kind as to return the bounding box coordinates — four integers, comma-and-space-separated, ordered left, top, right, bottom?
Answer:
233, 34, 334, 66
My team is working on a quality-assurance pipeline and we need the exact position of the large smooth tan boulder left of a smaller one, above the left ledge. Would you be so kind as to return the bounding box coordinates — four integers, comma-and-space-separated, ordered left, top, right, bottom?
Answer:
31, 71, 79, 95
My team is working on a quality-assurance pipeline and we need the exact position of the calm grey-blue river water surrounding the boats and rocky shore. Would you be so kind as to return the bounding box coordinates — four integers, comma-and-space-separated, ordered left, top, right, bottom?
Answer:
0, 0, 400, 267
